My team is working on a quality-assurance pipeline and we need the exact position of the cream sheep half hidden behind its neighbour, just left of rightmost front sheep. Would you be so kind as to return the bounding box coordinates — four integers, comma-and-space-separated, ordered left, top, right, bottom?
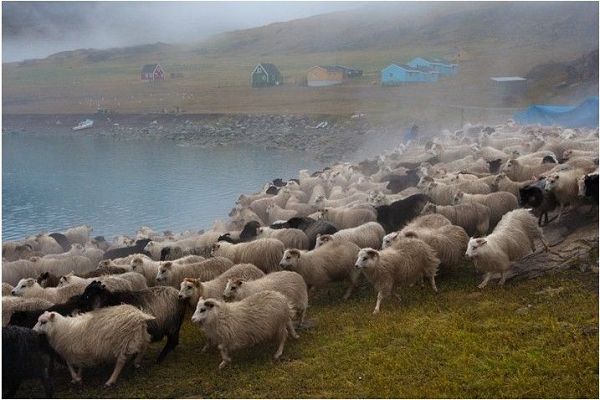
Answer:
392, 225, 469, 268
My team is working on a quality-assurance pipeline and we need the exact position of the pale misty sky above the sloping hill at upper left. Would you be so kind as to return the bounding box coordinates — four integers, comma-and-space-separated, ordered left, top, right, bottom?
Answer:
2, 1, 364, 62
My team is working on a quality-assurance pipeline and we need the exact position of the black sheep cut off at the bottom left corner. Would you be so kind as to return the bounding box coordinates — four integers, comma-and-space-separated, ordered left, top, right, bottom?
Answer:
2, 326, 54, 397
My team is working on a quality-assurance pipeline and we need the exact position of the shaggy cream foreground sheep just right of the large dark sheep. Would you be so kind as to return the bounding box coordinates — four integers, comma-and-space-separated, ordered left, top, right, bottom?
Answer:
192, 290, 298, 369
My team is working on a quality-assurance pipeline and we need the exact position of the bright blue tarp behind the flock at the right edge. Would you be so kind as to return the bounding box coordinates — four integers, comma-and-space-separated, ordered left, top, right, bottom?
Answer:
513, 96, 598, 128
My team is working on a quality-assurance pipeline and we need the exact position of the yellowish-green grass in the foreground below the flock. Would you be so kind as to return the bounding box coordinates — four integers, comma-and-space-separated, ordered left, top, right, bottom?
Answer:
18, 267, 598, 398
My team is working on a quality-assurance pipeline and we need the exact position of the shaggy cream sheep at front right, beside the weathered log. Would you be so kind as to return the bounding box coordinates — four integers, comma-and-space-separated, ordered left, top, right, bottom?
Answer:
465, 209, 548, 289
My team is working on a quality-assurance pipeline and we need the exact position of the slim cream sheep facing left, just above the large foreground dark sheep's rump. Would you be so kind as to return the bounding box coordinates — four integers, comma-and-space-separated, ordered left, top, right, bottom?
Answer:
156, 257, 233, 288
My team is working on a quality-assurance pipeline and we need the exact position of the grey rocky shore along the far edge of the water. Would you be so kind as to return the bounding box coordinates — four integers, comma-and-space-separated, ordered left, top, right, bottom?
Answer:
3, 114, 389, 162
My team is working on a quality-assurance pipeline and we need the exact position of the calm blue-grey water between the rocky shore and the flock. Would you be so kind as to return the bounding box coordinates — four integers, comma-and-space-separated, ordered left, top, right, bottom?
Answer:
2, 135, 320, 240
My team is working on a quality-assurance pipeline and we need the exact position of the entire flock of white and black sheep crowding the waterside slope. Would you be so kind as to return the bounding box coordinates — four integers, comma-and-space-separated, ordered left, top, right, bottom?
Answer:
2, 122, 598, 397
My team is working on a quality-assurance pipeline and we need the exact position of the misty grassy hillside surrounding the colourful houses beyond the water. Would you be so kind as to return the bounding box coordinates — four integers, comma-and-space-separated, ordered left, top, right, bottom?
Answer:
3, 3, 598, 115
